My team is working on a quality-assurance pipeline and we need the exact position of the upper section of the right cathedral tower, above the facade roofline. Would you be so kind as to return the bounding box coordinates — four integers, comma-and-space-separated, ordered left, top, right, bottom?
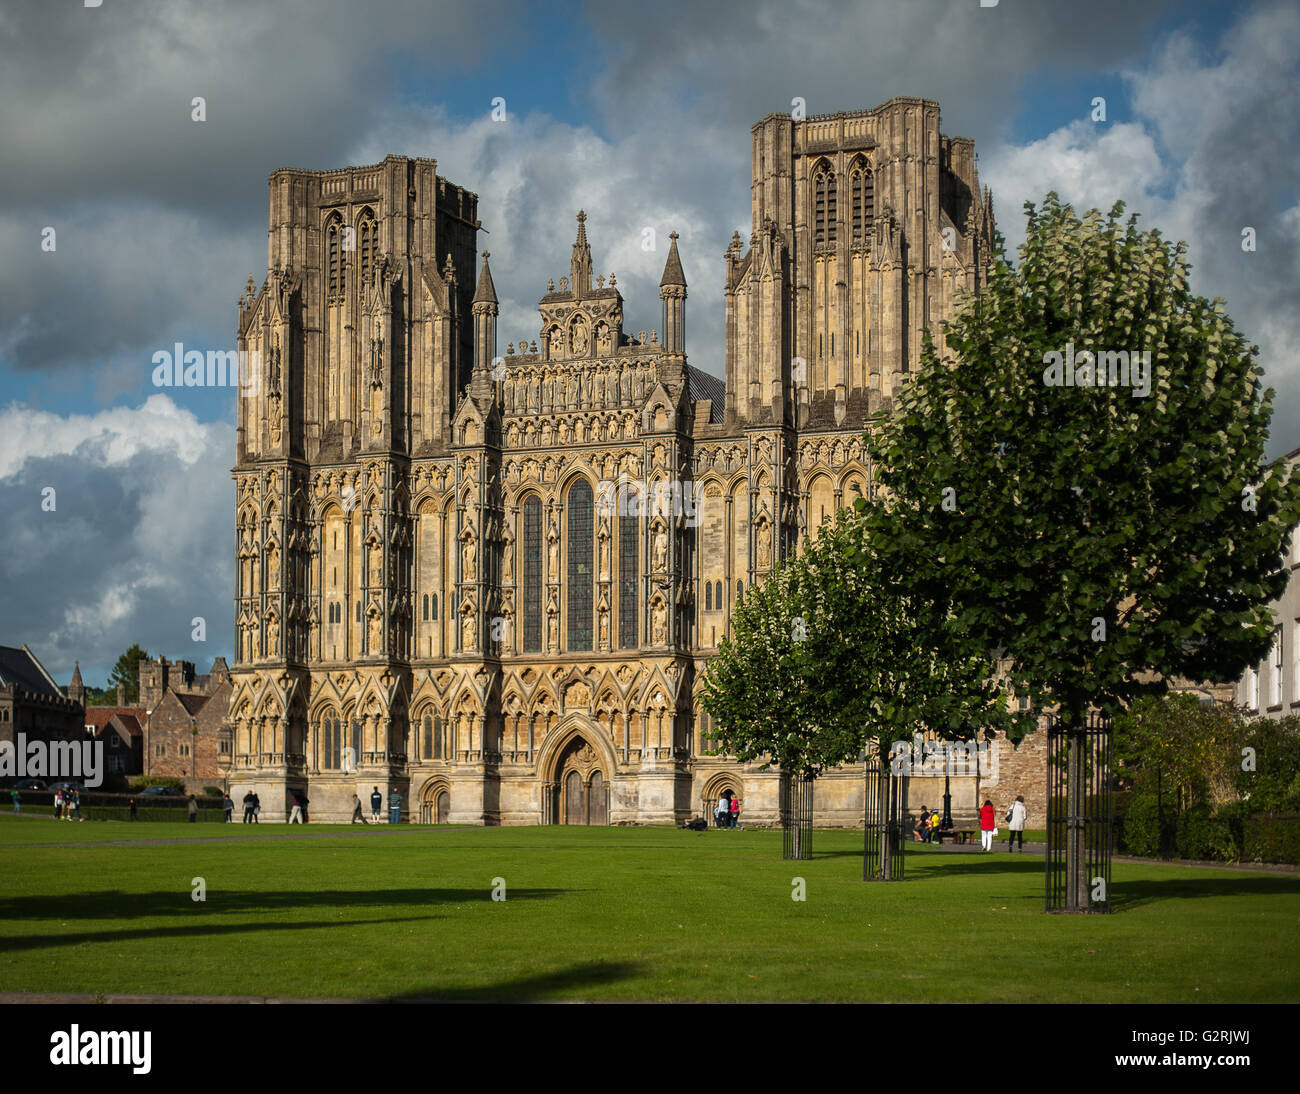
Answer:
725, 99, 993, 429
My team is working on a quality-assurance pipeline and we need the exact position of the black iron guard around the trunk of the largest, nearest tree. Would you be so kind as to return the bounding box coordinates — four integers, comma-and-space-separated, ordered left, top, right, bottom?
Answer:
1044, 712, 1114, 915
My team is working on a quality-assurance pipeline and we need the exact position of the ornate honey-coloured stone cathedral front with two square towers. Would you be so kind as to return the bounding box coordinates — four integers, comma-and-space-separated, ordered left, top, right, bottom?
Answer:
230, 99, 993, 825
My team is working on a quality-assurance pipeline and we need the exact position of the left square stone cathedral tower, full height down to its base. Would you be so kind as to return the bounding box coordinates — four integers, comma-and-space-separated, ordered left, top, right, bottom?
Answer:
230, 156, 481, 819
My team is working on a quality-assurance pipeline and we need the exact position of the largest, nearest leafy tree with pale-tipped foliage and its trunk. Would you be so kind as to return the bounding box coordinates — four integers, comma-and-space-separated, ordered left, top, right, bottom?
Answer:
867, 194, 1300, 911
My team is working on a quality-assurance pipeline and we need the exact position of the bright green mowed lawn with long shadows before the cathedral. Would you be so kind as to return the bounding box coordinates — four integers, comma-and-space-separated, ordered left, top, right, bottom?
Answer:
0, 817, 1300, 1003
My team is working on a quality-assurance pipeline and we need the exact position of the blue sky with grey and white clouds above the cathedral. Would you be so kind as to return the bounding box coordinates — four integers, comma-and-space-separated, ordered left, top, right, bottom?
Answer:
0, 0, 1300, 685
